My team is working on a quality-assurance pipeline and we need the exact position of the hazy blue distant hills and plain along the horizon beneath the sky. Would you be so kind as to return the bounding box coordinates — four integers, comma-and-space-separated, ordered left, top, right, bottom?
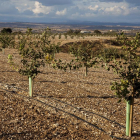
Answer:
0, 21, 140, 30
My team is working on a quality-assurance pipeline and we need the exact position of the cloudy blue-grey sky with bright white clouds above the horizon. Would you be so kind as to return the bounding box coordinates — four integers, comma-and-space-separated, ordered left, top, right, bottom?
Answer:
0, 0, 140, 23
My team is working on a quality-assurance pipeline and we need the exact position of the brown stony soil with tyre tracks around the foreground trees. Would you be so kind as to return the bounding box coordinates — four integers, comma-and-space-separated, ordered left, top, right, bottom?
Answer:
0, 49, 140, 140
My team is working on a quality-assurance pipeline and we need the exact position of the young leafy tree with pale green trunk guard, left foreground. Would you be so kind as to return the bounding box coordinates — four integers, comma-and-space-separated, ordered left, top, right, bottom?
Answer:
8, 38, 44, 97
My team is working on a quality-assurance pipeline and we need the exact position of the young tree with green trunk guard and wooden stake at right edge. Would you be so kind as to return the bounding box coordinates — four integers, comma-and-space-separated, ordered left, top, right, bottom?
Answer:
100, 33, 140, 137
